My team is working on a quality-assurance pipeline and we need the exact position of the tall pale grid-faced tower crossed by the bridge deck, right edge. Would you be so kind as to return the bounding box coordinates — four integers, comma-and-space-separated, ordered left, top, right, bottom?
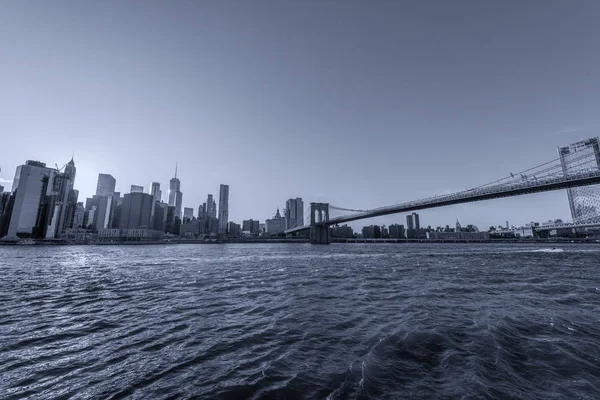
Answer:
558, 137, 600, 223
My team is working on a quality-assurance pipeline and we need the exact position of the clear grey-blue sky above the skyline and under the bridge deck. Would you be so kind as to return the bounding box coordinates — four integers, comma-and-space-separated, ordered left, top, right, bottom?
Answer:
0, 0, 600, 228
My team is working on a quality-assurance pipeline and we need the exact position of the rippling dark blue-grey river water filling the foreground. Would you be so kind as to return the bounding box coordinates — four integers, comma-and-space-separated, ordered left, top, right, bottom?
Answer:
0, 244, 600, 399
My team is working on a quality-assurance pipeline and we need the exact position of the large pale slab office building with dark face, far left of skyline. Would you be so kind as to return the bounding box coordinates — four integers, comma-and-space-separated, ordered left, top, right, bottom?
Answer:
6, 160, 58, 238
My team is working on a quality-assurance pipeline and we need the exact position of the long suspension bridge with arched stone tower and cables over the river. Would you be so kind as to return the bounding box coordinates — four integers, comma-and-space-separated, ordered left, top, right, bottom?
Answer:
285, 145, 600, 244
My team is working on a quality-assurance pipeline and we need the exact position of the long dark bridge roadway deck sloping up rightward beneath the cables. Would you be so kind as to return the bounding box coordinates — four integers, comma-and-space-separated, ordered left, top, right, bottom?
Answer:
285, 169, 600, 234
